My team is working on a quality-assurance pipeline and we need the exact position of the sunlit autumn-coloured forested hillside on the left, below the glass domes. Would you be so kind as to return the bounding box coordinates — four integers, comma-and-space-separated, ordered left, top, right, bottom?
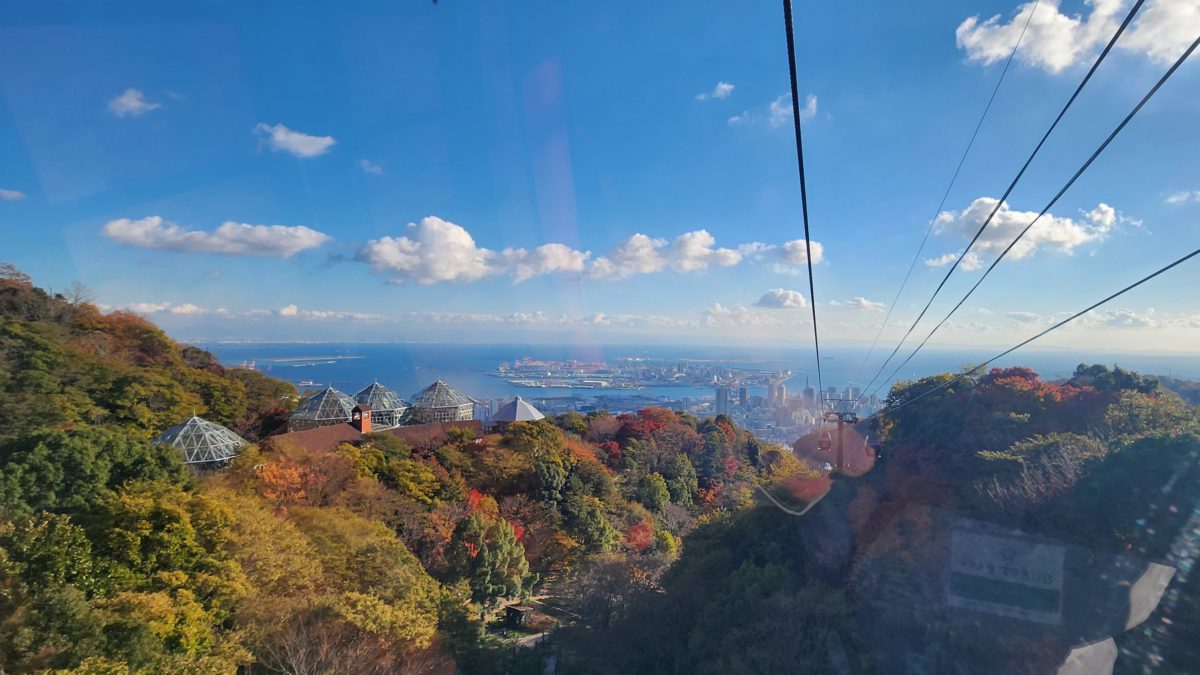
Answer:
0, 267, 820, 674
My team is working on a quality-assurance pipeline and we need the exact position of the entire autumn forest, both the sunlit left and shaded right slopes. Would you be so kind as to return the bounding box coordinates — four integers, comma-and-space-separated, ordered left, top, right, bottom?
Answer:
0, 268, 1200, 674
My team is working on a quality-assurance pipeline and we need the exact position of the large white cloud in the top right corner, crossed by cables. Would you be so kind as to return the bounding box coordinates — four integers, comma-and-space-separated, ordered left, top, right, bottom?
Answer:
955, 0, 1200, 73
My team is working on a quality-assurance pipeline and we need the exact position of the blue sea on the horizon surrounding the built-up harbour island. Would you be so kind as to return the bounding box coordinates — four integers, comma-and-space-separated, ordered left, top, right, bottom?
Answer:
200, 342, 1200, 400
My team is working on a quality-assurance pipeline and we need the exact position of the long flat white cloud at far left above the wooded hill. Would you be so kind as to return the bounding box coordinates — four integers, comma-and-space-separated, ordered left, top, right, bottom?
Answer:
102, 216, 330, 258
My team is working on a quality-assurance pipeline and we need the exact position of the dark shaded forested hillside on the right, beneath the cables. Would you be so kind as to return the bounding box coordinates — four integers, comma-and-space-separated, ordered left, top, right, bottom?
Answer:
564, 366, 1200, 674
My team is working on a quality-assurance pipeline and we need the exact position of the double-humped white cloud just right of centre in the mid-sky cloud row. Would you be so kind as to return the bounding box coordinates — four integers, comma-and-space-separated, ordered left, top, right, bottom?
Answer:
588, 229, 742, 279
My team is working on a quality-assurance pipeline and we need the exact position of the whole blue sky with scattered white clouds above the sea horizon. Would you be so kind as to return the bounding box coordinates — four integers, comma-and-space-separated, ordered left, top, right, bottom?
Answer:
0, 0, 1200, 351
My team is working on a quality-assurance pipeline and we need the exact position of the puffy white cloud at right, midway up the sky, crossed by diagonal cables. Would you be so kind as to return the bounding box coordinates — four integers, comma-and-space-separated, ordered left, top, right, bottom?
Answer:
925, 197, 1123, 261
